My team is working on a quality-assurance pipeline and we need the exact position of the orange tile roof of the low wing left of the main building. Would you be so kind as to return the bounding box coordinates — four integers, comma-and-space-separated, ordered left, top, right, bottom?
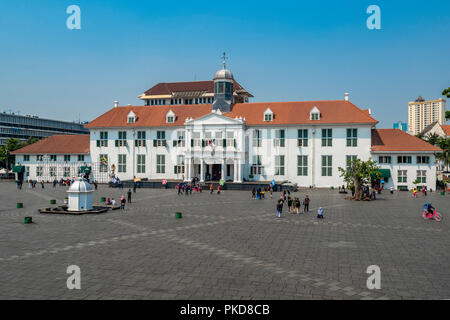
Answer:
12, 134, 89, 154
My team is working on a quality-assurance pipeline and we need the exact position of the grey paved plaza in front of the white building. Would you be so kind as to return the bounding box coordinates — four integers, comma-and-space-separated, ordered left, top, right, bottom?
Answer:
0, 182, 450, 299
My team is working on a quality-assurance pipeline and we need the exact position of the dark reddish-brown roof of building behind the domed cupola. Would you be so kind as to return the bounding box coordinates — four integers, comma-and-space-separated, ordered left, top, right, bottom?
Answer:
144, 80, 250, 95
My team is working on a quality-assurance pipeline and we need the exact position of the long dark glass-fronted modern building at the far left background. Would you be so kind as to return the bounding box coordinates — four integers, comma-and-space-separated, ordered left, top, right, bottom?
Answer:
0, 112, 89, 145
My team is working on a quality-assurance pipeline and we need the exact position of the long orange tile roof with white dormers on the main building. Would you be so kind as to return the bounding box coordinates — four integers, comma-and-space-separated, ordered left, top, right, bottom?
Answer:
85, 100, 378, 128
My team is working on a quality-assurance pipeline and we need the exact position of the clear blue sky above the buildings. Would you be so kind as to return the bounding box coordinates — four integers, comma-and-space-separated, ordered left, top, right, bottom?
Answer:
0, 0, 450, 128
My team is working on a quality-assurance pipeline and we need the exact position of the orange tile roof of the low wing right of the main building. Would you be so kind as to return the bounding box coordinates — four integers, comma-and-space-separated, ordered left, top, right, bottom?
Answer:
372, 129, 442, 152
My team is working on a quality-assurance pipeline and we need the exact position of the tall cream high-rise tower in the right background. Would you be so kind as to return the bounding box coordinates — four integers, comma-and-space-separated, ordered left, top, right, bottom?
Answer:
408, 96, 446, 135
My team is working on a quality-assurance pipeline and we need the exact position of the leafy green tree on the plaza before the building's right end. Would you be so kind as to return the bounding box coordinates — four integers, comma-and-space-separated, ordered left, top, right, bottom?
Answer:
338, 159, 381, 201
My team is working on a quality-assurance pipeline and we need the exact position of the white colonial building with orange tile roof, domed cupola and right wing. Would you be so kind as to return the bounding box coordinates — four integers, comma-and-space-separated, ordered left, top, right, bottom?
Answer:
11, 65, 440, 188
